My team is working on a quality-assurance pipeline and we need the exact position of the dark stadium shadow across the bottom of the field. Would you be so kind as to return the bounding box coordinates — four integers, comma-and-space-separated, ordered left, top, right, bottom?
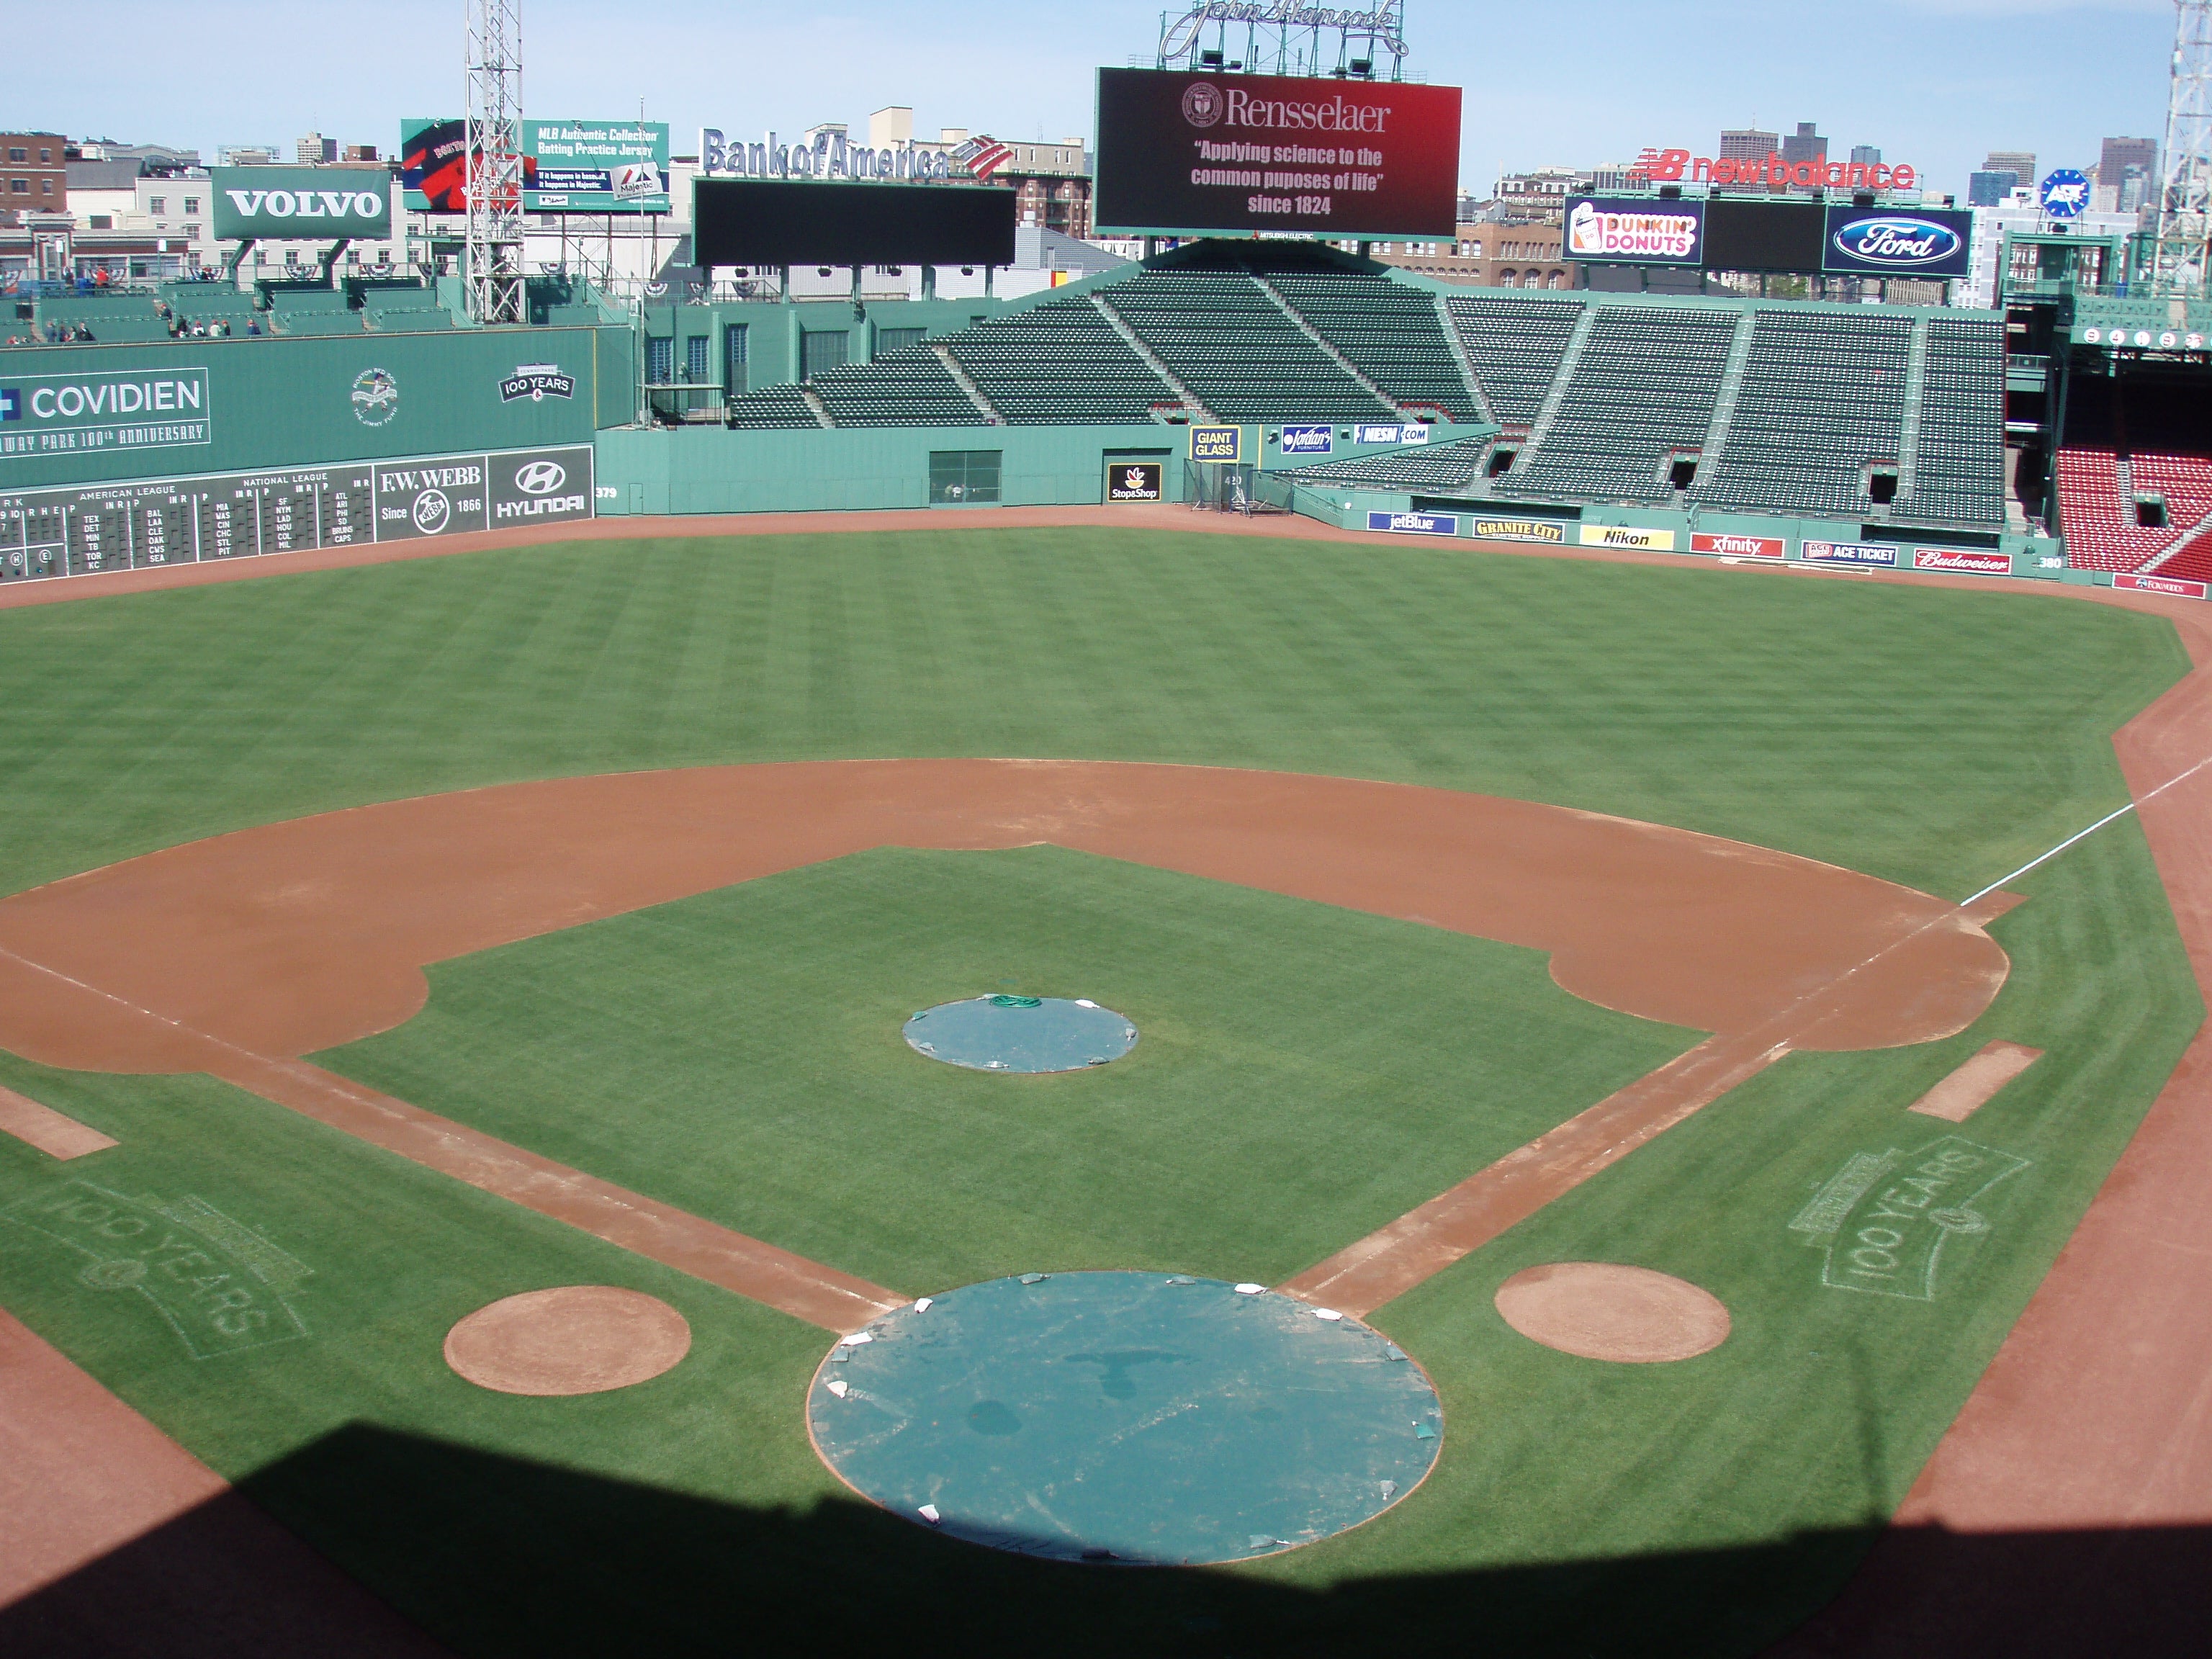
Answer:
0, 1426, 2212, 1659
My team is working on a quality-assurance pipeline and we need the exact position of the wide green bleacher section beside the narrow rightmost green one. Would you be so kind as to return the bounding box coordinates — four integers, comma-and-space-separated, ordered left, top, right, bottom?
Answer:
1690, 305, 1913, 518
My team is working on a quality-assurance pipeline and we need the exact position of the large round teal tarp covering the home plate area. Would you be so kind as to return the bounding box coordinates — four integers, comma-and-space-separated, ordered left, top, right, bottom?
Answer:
807, 1272, 1442, 1566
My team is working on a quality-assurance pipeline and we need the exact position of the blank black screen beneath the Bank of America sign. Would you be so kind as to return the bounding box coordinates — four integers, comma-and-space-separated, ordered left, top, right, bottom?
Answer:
693, 179, 1015, 266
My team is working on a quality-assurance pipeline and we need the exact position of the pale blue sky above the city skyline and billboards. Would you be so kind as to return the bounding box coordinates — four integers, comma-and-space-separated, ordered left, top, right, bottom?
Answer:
30, 0, 2175, 190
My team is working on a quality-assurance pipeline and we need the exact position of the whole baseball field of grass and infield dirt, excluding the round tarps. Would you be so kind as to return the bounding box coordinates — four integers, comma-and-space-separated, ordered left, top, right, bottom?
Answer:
0, 516, 2206, 1655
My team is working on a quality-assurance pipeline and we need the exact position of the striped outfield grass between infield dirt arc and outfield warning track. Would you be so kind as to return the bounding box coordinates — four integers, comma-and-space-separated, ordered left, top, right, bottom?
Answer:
0, 529, 2185, 894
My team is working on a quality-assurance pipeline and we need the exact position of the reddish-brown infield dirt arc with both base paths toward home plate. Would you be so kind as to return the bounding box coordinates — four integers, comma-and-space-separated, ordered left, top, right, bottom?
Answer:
0, 761, 2006, 1331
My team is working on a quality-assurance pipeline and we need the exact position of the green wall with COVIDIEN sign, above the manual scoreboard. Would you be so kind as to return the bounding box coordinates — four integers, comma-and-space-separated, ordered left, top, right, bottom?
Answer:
0, 328, 635, 495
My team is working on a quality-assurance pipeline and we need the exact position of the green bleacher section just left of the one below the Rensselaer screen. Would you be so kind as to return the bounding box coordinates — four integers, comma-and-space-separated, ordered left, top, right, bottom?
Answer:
943, 299, 1174, 427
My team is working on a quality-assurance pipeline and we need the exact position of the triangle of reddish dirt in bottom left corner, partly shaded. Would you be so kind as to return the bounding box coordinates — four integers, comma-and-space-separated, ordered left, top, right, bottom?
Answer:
0, 1312, 444, 1659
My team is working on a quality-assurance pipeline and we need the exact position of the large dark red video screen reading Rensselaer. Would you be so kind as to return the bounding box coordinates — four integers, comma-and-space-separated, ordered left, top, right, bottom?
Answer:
1095, 68, 1460, 241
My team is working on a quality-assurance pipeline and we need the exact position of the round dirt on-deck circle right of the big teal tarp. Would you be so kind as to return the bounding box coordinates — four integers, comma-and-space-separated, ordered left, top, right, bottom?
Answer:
1498, 1261, 1727, 1364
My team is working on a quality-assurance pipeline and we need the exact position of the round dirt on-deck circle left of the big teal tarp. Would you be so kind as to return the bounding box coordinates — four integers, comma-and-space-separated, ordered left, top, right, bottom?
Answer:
444, 1285, 690, 1393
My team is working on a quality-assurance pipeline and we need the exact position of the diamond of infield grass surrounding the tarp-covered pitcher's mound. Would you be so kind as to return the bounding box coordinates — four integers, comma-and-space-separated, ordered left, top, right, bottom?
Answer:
318, 848, 1696, 1294
